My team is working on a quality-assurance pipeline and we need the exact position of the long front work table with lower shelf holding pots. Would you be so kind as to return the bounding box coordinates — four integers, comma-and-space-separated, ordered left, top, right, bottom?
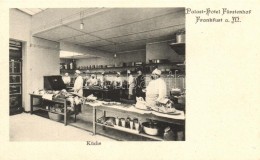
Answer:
89, 103, 185, 141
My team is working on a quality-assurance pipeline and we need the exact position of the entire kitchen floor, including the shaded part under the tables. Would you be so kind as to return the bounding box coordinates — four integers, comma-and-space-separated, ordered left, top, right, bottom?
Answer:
10, 106, 184, 141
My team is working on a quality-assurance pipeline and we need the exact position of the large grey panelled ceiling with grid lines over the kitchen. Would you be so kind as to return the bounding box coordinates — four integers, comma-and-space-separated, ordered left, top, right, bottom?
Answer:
33, 8, 185, 58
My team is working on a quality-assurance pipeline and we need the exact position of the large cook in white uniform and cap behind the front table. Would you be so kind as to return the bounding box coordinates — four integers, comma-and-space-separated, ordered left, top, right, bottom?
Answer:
146, 68, 167, 108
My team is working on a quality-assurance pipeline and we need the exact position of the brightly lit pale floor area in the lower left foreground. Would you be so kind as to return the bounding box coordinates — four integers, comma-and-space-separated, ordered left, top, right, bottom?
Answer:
10, 113, 113, 141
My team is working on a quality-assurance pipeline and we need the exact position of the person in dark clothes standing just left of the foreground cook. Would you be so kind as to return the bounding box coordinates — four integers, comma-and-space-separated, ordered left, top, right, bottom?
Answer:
135, 70, 145, 99
